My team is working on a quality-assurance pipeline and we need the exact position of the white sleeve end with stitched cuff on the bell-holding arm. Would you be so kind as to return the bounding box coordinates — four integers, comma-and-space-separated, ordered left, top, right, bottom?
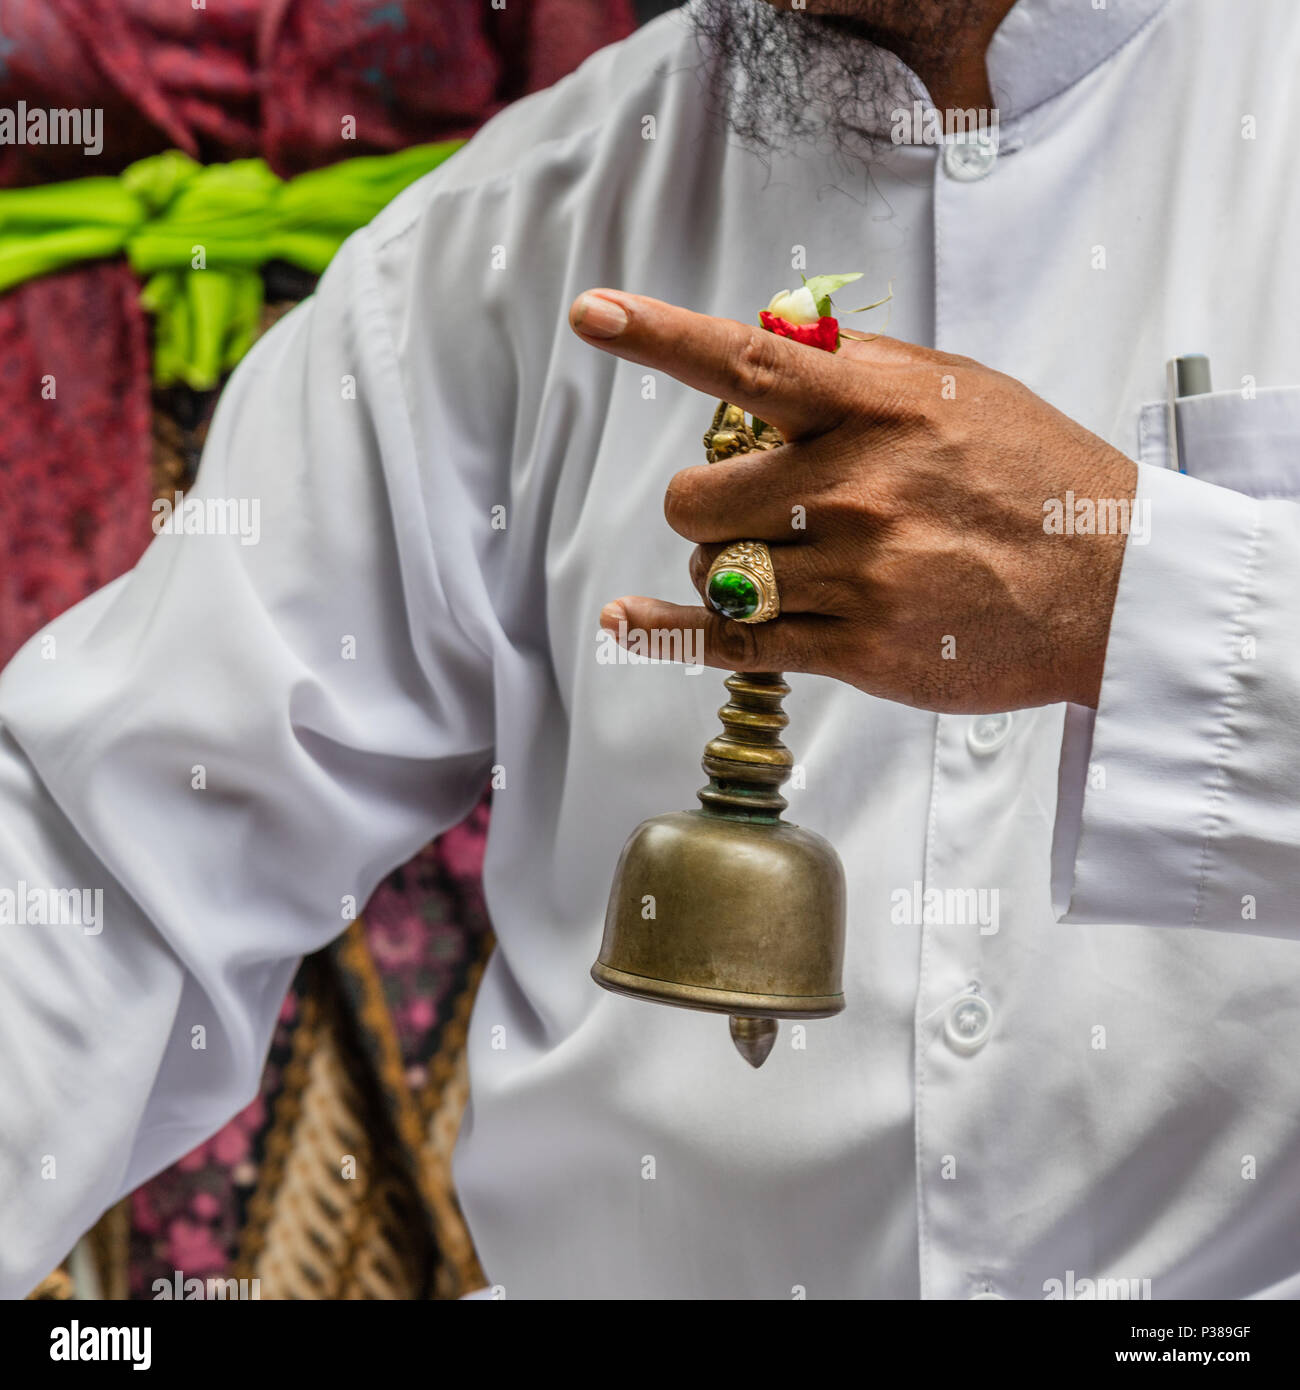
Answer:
1053, 466, 1300, 938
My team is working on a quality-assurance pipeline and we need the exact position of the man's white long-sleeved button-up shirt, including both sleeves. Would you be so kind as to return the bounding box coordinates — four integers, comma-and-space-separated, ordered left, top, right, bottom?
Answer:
0, 0, 1300, 1298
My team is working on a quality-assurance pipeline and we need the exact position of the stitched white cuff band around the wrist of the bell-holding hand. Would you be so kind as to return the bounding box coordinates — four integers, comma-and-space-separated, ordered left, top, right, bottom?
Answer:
1053, 466, 1260, 926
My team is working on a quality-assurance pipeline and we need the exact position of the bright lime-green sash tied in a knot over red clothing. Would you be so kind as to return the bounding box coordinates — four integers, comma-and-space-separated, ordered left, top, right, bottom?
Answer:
0, 140, 464, 391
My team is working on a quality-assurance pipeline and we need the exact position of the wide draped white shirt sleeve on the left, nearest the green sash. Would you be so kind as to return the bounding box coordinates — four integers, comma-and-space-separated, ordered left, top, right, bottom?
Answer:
0, 222, 494, 1297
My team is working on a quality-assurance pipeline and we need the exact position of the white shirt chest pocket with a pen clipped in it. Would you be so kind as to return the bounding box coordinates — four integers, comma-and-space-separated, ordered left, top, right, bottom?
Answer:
1137, 386, 1300, 498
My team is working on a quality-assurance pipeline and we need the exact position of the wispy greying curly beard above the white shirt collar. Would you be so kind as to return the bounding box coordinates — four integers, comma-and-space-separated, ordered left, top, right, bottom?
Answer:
687, 0, 969, 157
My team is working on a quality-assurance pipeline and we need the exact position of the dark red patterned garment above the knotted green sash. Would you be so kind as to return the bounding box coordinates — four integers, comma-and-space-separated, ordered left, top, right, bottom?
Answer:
0, 0, 634, 185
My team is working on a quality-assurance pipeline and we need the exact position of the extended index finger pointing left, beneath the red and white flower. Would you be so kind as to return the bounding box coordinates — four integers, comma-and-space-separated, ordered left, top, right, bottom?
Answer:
569, 289, 852, 439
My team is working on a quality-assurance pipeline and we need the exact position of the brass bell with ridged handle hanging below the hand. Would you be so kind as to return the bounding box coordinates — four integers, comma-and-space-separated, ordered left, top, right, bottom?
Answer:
591, 673, 844, 1066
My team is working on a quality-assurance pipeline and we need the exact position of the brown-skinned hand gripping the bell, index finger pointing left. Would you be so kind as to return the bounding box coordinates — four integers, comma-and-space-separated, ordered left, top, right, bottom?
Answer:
570, 289, 1137, 713
